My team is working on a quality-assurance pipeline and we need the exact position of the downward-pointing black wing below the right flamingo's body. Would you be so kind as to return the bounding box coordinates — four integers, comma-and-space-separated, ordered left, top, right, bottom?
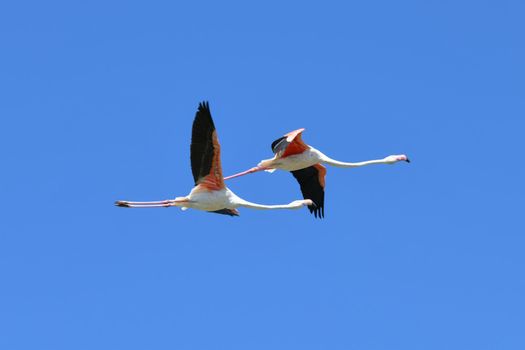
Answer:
291, 164, 326, 218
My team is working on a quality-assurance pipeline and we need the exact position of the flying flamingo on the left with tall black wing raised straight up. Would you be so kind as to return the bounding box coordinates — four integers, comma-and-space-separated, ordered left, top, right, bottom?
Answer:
115, 102, 314, 216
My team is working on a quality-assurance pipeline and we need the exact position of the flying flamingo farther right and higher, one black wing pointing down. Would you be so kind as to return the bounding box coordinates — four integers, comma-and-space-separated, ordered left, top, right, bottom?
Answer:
224, 128, 410, 218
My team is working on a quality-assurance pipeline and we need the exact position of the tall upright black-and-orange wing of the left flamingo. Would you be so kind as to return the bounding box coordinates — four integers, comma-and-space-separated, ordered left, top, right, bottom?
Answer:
190, 102, 224, 190
